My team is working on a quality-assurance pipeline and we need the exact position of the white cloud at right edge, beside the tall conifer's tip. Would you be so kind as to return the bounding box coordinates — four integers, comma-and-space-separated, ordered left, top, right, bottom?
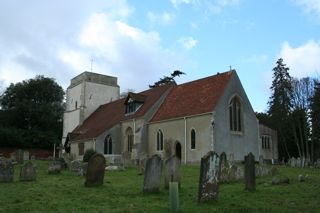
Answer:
280, 40, 320, 78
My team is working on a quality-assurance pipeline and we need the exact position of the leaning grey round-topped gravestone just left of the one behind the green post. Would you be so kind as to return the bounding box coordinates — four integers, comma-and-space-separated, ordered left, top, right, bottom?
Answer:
143, 155, 162, 193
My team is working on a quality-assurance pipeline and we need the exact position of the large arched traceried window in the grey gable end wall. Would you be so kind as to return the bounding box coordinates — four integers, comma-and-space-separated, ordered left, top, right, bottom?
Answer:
229, 97, 242, 132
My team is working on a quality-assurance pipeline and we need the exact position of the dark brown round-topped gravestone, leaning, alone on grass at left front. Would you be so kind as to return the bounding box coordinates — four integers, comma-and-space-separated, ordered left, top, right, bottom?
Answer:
84, 154, 106, 187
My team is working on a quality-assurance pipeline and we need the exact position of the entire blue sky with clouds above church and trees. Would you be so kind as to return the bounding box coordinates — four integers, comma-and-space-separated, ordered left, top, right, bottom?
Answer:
0, 0, 320, 111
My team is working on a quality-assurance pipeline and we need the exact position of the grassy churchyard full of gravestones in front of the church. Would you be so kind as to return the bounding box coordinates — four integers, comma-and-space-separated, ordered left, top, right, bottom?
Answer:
0, 152, 320, 212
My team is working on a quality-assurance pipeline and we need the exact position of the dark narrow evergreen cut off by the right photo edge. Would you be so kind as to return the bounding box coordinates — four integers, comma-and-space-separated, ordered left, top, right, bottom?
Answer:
310, 81, 320, 161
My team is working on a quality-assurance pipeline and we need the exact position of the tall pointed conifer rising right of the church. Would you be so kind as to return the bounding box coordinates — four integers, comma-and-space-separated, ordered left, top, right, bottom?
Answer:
268, 58, 293, 159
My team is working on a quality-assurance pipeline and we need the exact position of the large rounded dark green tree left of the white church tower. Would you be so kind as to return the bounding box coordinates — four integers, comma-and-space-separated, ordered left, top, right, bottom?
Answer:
0, 76, 64, 148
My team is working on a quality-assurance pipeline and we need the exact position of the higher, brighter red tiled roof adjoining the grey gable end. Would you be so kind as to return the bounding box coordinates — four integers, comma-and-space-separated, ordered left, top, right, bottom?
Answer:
150, 71, 233, 122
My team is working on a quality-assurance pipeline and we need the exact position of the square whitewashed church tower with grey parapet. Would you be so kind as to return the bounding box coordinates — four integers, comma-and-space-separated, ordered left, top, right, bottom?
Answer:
62, 71, 120, 144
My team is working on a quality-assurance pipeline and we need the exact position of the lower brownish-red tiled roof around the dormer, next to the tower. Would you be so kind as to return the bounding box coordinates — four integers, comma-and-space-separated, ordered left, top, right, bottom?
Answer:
72, 86, 172, 141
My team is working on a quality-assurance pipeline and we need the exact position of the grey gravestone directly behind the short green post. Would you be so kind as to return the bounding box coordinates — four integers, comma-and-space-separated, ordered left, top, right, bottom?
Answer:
164, 156, 181, 189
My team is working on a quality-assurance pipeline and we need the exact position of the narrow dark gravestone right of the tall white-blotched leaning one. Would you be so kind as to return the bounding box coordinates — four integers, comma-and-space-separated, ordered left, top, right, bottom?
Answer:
244, 152, 256, 191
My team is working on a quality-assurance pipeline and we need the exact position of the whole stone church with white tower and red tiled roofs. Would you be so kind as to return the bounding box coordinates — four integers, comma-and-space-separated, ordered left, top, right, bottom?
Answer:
63, 70, 277, 164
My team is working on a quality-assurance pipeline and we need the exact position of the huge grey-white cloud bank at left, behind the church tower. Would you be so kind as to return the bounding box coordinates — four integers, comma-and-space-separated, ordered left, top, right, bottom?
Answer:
0, 0, 184, 91
